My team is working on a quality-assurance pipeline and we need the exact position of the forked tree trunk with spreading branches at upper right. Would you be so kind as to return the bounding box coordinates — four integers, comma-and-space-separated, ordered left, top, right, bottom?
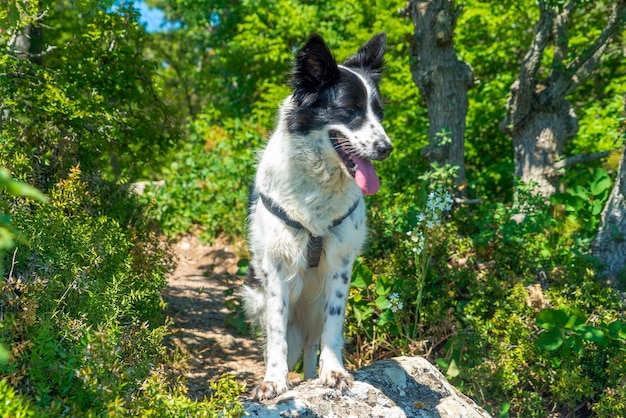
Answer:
501, 0, 626, 197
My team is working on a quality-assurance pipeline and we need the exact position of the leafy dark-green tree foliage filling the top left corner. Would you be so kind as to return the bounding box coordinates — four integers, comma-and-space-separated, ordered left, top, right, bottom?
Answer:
0, 0, 180, 186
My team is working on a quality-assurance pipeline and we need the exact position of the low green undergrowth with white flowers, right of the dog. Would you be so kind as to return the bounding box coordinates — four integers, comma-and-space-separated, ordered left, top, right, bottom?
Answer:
347, 178, 626, 417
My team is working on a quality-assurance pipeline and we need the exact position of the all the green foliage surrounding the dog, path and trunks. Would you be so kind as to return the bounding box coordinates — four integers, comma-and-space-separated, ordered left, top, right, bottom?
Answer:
0, 0, 626, 417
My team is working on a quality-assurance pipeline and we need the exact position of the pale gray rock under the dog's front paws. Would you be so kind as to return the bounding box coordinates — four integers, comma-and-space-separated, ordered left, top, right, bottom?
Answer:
244, 357, 490, 418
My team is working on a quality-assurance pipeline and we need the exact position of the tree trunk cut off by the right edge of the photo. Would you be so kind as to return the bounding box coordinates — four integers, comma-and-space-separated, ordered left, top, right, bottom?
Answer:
591, 95, 626, 289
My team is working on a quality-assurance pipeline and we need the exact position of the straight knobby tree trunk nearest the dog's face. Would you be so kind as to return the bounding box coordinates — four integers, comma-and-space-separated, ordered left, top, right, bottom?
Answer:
404, 0, 474, 196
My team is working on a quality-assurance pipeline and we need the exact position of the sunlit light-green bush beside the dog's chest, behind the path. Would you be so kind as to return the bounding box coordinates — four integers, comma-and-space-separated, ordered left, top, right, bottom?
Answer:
145, 116, 267, 241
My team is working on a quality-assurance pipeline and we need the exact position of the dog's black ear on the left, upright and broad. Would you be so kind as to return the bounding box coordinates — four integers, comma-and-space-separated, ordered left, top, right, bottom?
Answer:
291, 34, 339, 105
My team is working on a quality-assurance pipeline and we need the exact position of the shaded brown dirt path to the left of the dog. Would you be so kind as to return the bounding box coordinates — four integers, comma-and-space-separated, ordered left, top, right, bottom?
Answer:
164, 236, 264, 400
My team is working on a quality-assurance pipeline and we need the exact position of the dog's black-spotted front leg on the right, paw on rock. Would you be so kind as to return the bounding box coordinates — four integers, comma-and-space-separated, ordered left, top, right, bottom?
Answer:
319, 255, 354, 389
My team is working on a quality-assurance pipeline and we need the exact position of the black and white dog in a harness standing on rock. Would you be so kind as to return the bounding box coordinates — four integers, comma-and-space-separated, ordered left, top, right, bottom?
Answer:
244, 33, 392, 400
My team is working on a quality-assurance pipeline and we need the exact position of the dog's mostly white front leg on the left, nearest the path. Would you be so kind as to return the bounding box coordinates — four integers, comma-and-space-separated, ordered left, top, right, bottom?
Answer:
253, 262, 289, 401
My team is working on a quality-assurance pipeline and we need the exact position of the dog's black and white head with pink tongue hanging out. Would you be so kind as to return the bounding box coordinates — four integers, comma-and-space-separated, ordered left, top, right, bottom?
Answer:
287, 33, 392, 194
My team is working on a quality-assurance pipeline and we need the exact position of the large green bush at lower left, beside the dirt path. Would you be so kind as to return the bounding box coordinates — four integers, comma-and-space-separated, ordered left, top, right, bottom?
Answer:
0, 169, 242, 416
